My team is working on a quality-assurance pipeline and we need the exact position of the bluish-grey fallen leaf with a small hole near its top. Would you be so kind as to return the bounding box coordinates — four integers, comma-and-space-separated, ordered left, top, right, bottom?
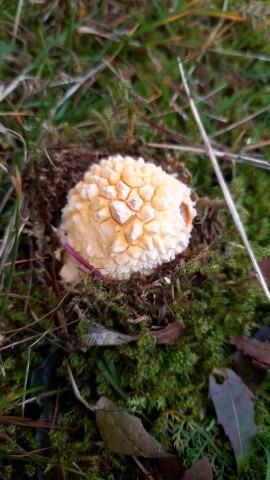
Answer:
209, 368, 257, 471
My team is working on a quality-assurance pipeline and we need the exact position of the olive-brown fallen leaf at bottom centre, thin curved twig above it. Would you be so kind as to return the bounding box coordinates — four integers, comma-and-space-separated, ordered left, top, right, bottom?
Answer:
96, 397, 170, 458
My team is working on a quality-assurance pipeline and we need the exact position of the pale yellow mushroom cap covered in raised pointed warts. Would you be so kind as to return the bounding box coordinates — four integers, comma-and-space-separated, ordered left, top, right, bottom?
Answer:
60, 155, 196, 282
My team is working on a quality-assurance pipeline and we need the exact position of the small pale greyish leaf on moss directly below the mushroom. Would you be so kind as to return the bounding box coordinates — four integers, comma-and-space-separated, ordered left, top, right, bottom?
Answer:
81, 323, 138, 347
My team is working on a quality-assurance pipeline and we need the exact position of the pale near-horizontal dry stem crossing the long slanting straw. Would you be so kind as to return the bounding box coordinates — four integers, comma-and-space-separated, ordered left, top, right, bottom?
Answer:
146, 143, 270, 170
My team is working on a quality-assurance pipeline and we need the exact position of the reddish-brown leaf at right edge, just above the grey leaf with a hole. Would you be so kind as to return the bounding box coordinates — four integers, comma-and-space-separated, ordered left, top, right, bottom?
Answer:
231, 337, 270, 365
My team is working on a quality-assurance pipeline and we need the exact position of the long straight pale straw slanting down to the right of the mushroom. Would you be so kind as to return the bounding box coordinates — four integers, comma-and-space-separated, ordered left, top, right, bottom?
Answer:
178, 58, 270, 302
